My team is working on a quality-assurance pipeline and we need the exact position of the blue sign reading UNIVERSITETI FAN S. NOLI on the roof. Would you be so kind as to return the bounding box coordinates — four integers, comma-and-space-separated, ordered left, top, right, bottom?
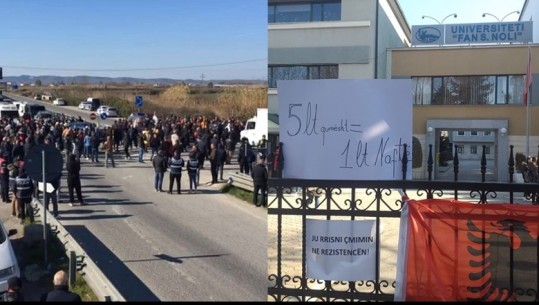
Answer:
412, 21, 533, 46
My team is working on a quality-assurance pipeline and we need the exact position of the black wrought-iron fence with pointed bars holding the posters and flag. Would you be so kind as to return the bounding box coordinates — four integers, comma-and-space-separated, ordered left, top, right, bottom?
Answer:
268, 146, 539, 302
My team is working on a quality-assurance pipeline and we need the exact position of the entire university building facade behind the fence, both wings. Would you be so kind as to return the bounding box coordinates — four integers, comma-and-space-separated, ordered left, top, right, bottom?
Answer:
268, 0, 539, 181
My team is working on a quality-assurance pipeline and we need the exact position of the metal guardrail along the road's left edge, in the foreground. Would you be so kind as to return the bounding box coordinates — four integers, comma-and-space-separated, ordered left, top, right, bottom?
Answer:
36, 199, 126, 302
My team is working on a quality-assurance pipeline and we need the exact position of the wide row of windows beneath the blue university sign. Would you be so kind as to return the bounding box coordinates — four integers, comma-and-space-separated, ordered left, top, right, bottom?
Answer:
412, 75, 524, 105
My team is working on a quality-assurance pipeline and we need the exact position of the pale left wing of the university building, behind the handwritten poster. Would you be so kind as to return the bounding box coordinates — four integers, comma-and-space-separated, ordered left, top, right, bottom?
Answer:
268, 0, 410, 150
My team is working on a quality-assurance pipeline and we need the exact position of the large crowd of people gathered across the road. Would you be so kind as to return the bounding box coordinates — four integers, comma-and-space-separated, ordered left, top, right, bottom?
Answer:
0, 107, 278, 222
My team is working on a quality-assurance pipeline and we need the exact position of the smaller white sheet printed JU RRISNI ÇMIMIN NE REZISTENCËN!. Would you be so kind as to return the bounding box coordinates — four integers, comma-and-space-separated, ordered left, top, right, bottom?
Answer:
305, 219, 377, 281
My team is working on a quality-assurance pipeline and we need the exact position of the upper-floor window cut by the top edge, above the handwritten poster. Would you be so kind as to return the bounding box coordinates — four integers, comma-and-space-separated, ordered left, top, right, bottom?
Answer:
268, 0, 341, 23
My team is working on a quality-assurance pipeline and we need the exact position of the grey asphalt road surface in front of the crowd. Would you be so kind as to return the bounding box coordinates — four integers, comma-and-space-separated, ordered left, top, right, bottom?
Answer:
3, 92, 267, 301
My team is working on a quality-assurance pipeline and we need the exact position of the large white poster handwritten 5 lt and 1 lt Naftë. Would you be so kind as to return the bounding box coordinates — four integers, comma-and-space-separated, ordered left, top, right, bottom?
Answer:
277, 79, 412, 180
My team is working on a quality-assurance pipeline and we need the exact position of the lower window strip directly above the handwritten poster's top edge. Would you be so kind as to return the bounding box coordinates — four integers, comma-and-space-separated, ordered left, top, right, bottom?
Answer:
268, 65, 339, 88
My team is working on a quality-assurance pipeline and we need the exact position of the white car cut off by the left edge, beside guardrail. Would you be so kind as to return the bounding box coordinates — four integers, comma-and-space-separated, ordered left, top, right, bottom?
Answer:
0, 220, 21, 294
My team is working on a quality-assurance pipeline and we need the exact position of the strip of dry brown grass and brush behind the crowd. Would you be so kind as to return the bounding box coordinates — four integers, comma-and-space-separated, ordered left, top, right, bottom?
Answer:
17, 84, 267, 119
